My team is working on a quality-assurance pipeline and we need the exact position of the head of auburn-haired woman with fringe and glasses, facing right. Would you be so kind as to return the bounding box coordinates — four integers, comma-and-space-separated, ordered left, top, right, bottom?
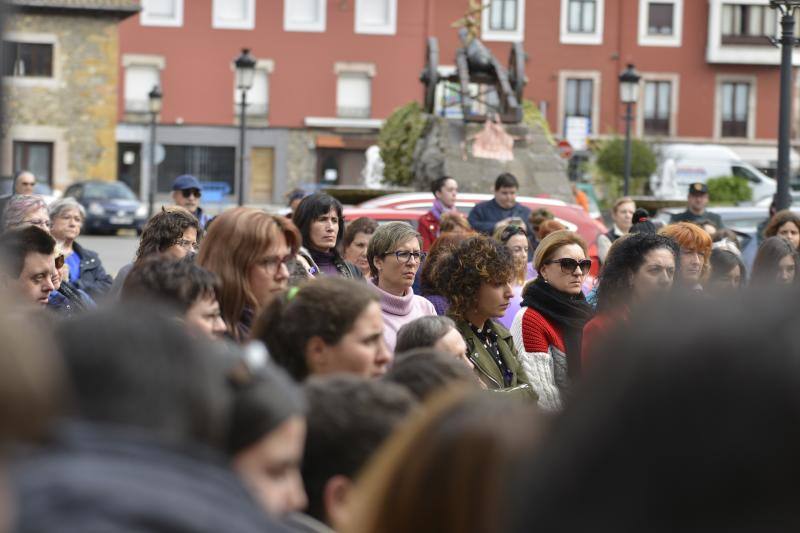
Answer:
197, 207, 300, 343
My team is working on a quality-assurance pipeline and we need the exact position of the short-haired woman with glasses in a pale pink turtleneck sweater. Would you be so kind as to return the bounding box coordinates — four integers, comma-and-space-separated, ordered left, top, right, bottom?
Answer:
367, 222, 436, 352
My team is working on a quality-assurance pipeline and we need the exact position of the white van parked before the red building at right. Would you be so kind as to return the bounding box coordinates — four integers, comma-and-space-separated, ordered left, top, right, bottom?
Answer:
650, 144, 777, 202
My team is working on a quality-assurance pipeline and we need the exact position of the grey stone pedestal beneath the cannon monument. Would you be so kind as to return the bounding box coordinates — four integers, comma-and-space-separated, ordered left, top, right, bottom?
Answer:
414, 117, 575, 203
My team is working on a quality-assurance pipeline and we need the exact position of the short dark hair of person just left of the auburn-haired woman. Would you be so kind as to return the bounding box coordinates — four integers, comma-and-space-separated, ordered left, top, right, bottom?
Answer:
121, 255, 220, 313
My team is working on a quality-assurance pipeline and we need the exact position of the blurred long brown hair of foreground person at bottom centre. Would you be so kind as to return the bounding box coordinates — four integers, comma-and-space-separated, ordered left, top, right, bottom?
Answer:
344, 389, 541, 533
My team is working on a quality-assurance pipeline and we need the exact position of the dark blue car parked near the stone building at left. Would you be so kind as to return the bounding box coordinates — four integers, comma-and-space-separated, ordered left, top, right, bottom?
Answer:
64, 181, 147, 233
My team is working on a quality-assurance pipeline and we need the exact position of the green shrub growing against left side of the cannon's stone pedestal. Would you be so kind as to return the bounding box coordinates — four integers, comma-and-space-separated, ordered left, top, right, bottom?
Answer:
378, 102, 427, 186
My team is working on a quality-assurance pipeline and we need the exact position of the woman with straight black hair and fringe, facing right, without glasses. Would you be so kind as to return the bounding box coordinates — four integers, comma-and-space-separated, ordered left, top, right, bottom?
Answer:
292, 193, 363, 279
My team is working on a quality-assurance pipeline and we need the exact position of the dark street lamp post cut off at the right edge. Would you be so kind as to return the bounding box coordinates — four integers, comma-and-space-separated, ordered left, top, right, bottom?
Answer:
769, 0, 800, 211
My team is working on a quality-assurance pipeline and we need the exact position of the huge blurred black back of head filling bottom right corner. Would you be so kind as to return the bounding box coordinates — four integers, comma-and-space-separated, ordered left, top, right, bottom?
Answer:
504, 290, 800, 532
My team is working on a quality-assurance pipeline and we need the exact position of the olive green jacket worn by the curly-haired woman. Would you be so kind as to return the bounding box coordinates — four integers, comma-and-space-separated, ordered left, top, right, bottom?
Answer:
452, 317, 539, 402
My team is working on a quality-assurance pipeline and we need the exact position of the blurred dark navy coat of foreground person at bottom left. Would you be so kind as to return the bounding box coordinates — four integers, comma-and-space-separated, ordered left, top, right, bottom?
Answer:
13, 423, 285, 533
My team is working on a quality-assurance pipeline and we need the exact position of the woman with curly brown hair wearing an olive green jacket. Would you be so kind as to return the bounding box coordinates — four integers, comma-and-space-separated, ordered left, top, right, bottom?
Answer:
436, 235, 538, 400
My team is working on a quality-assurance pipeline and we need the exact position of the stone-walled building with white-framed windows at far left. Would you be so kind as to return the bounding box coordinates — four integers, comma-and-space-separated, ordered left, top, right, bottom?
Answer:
0, 0, 139, 189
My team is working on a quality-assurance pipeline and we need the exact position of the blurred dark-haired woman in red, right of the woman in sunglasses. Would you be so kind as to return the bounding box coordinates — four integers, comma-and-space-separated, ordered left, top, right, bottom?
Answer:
581, 233, 680, 367
